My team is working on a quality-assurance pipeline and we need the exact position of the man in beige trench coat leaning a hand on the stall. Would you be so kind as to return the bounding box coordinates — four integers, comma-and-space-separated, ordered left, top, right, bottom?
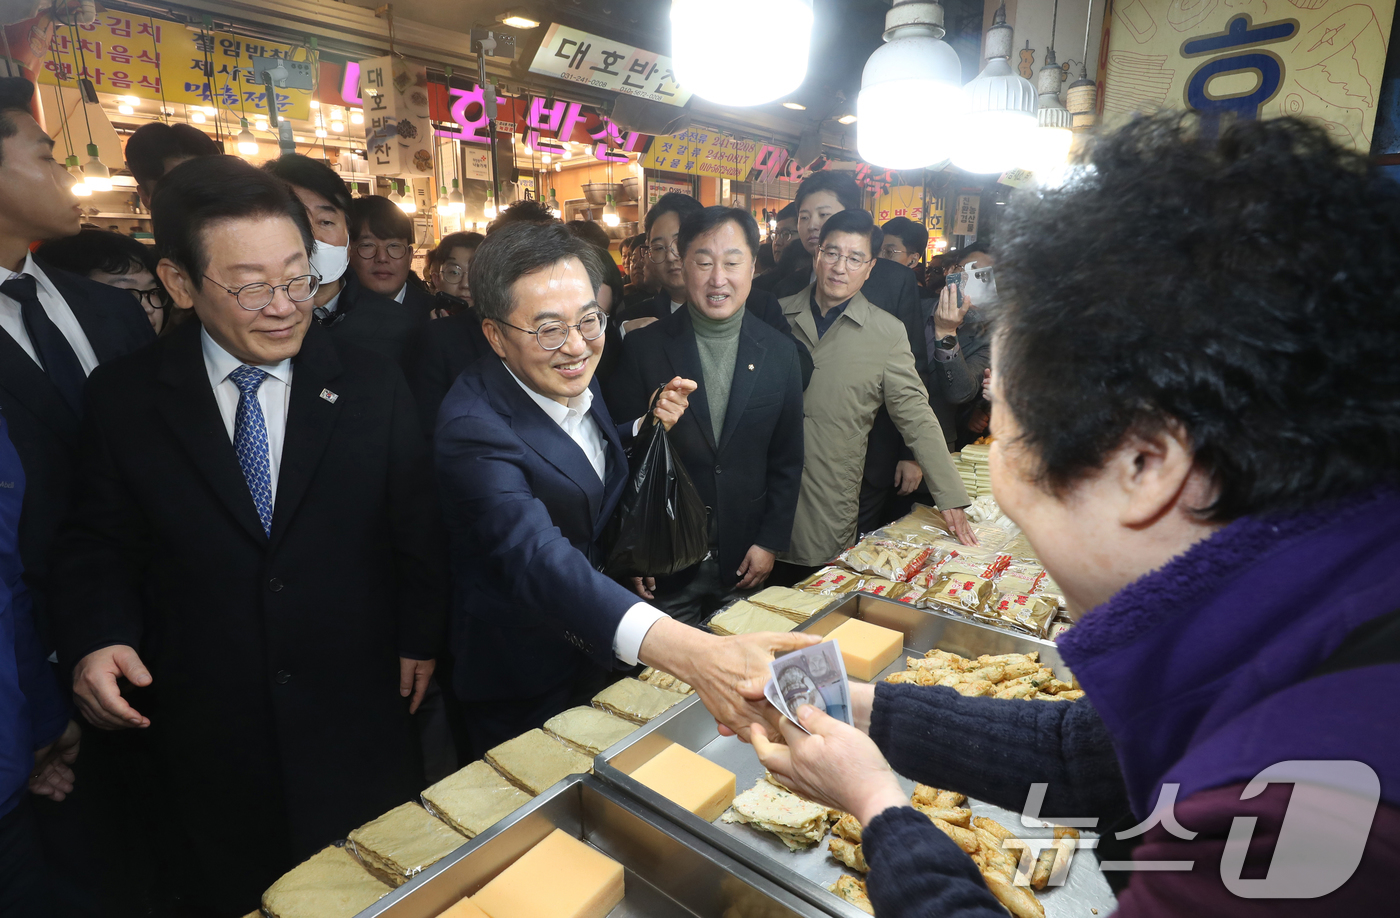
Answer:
780, 210, 976, 567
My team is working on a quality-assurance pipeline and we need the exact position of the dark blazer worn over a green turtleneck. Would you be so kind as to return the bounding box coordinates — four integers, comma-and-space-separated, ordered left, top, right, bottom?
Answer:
609, 309, 802, 589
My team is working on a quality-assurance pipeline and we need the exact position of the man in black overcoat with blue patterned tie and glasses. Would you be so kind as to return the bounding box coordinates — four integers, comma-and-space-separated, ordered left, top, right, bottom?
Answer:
53, 157, 447, 917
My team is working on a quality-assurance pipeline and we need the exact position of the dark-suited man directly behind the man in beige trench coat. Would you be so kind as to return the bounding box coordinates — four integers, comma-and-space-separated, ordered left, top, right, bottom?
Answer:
773, 171, 928, 532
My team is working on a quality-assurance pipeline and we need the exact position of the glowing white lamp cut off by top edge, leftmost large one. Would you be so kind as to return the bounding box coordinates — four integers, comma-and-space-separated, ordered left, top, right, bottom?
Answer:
671, 0, 812, 106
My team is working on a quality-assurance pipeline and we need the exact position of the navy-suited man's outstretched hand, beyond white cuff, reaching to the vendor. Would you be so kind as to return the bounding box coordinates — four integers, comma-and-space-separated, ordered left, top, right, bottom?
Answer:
640, 617, 820, 742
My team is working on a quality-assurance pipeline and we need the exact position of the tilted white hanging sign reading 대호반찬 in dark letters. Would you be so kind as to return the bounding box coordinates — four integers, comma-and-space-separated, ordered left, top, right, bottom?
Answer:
529, 22, 690, 105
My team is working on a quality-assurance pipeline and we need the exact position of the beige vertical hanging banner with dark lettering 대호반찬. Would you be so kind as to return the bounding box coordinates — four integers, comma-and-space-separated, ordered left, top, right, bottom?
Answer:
360, 57, 433, 176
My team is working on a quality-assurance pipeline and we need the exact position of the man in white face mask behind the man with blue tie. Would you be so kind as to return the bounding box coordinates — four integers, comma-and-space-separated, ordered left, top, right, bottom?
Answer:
263, 153, 426, 369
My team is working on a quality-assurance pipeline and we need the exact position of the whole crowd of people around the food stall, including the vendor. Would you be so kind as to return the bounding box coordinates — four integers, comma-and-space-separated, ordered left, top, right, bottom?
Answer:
0, 64, 1400, 918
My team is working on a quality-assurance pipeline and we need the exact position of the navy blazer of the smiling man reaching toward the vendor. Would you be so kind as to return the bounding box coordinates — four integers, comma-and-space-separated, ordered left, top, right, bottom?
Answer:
434, 360, 640, 701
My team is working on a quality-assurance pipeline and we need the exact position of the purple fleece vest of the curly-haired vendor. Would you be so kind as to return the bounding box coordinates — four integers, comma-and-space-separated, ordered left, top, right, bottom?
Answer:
1058, 490, 1400, 819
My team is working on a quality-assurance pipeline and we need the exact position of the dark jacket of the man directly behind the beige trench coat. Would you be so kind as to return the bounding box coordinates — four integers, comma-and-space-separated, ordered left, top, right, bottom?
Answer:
773, 257, 928, 488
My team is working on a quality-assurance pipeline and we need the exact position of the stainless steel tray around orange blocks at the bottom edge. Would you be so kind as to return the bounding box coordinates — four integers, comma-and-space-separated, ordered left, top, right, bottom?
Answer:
357, 775, 820, 918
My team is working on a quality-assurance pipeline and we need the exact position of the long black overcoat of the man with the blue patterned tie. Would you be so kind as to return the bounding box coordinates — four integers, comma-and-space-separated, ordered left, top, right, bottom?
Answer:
53, 322, 447, 914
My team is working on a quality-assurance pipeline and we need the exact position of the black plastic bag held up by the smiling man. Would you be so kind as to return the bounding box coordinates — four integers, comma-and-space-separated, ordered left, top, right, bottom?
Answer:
603, 392, 710, 577
